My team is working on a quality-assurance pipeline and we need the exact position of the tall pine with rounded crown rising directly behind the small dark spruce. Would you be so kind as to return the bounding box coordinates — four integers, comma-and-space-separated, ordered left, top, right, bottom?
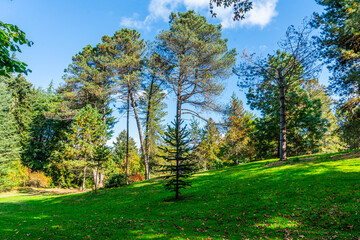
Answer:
157, 11, 236, 150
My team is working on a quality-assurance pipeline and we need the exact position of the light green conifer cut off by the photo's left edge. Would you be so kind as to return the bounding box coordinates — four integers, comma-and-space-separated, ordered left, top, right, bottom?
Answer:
0, 83, 21, 191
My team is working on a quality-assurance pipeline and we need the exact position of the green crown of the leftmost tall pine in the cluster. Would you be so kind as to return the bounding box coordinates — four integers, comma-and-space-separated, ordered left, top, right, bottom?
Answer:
58, 45, 115, 122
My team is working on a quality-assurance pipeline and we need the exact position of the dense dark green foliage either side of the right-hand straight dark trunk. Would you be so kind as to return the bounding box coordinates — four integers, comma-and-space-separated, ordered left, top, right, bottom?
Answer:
247, 72, 327, 158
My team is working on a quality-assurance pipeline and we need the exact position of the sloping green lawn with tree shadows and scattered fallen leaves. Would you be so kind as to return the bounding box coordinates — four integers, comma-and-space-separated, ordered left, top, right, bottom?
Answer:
0, 153, 360, 239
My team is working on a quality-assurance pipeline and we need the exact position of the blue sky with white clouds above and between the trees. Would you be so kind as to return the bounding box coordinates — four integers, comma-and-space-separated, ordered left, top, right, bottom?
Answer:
0, 0, 329, 144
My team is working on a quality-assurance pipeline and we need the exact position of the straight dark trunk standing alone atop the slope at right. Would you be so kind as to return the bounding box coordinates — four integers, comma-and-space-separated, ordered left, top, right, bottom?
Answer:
279, 71, 287, 161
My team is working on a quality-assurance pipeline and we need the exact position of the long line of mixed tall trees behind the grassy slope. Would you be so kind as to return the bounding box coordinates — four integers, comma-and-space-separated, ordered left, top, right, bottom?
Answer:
0, 1, 360, 190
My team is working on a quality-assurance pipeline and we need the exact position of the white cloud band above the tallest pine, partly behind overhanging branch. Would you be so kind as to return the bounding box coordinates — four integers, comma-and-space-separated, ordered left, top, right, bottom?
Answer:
120, 0, 278, 30
